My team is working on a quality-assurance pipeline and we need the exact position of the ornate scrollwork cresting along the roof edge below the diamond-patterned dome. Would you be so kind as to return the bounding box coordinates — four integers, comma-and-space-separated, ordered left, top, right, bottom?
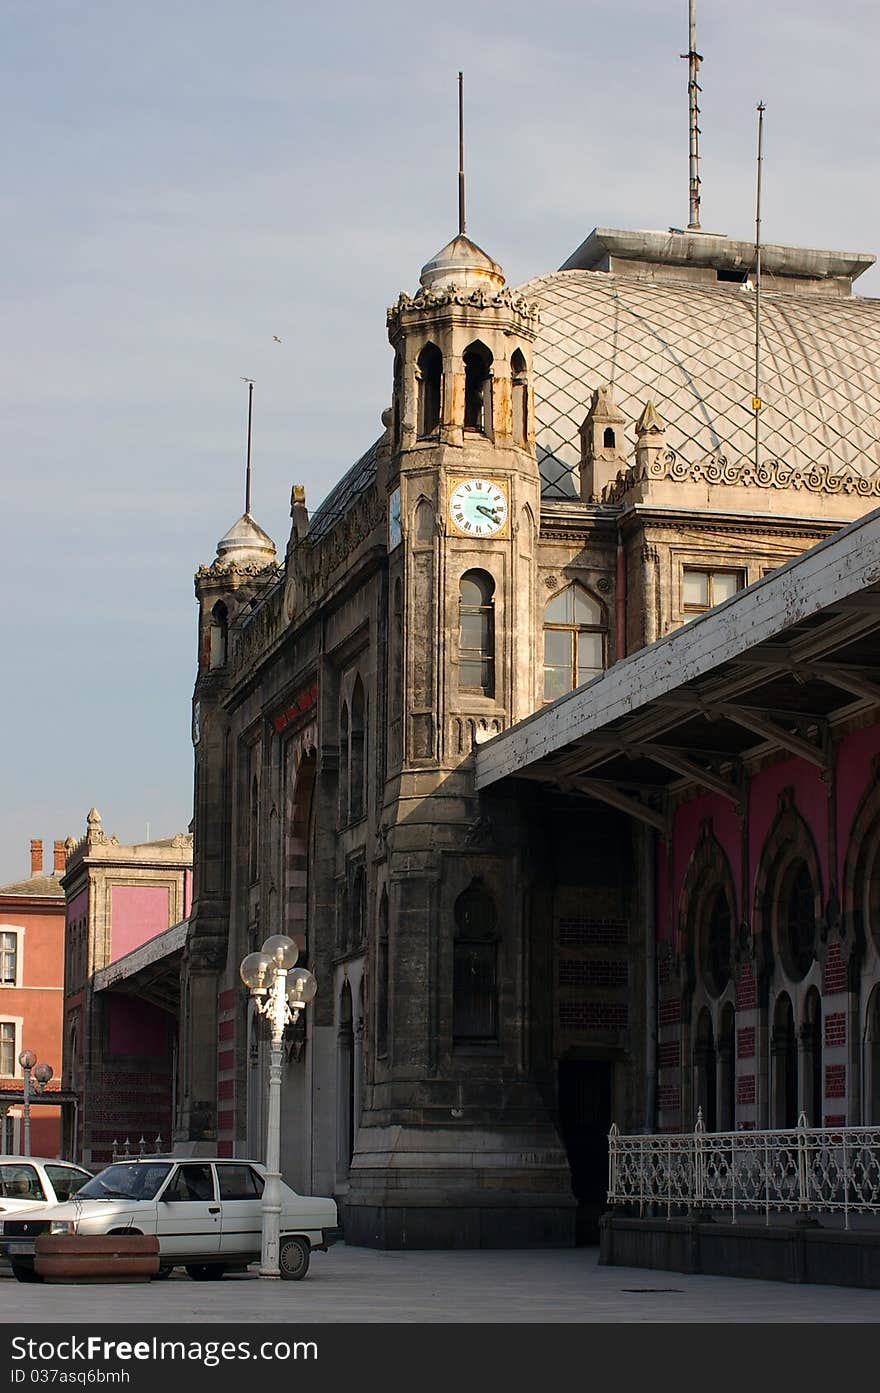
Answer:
602, 450, 880, 503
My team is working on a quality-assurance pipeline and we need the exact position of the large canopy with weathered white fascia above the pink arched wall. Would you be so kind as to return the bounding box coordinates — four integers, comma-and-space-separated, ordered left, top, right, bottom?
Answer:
476, 510, 880, 832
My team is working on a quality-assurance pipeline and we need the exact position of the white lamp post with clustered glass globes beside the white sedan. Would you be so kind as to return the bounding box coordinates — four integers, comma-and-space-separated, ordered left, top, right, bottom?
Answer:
238, 933, 317, 1277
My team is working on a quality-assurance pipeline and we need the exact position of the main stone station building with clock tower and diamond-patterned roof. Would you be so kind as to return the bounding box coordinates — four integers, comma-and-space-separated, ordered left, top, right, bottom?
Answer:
175, 222, 880, 1247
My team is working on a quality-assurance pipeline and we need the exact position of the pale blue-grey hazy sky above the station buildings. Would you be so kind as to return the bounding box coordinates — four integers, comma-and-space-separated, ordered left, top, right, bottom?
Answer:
0, 0, 880, 885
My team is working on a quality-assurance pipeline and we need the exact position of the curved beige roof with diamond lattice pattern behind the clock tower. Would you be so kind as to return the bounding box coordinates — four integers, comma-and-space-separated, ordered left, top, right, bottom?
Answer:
518, 270, 880, 499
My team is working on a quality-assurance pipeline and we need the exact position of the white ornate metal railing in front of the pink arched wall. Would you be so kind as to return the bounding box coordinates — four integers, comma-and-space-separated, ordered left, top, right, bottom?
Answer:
608, 1110, 880, 1227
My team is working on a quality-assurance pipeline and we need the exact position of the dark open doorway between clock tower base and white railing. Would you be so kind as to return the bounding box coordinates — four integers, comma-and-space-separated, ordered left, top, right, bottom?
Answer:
558, 1059, 611, 1244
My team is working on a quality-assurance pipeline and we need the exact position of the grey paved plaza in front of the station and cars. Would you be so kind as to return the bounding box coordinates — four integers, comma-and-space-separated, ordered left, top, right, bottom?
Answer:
0, 1244, 880, 1325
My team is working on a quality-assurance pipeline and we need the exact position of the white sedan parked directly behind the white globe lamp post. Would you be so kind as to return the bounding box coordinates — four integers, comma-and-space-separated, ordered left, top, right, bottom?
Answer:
0, 1156, 340, 1282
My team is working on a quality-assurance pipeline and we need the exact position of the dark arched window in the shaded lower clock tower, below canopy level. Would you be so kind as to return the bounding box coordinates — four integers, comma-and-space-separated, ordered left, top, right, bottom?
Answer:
453, 882, 498, 1045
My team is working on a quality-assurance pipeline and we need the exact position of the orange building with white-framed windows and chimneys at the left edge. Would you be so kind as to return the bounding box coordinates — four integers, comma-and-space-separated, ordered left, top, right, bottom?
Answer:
0, 840, 64, 1156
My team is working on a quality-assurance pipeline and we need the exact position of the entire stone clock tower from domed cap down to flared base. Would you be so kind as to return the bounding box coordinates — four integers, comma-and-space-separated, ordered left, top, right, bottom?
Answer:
345, 234, 574, 1247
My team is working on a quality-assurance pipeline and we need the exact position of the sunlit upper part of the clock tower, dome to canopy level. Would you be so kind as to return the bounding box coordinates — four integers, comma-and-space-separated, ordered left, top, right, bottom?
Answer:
388, 234, 540, 766
